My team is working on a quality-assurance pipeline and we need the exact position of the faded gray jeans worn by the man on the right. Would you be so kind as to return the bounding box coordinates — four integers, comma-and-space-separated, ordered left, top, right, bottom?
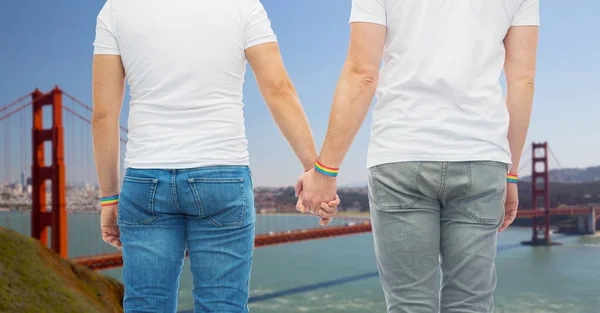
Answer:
368, 161, 508, 313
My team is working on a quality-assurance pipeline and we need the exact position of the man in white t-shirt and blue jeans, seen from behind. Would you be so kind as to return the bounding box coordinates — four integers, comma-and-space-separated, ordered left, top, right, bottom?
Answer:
92, 0, 339, 313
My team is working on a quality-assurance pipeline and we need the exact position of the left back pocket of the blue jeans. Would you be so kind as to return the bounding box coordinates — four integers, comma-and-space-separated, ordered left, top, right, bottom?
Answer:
117, 176, 158, 225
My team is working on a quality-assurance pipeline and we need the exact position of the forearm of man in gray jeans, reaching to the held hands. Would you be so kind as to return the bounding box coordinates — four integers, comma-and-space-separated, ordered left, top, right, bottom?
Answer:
319, 66, 378, 168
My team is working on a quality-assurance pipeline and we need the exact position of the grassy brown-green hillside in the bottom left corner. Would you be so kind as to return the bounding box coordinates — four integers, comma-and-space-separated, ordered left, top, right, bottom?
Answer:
0, 227, 124, 313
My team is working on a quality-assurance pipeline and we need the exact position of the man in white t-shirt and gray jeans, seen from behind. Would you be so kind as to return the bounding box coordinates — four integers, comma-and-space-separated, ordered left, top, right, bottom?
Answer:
297, 0, 539, 313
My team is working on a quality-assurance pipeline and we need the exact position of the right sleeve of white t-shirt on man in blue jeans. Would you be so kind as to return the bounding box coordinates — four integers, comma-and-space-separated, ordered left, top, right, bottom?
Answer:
244, 0, 277, 49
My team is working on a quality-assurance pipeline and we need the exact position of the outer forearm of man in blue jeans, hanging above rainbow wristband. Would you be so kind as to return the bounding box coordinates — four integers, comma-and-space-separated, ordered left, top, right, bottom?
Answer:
92, 116, 120, 197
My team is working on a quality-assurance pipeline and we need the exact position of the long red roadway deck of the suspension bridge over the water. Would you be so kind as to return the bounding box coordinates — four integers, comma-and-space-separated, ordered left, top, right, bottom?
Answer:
73, 207, 600, 270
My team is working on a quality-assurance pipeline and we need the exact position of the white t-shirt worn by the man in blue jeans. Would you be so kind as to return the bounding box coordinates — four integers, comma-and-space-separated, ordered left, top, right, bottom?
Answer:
94, 0, 277, 169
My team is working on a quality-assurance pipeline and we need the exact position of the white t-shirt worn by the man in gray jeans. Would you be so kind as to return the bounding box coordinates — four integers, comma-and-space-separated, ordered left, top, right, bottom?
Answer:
350, 0, 539, 167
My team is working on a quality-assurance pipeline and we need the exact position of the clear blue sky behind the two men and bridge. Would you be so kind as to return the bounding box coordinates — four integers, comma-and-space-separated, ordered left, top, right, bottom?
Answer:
0, 0, 600, 186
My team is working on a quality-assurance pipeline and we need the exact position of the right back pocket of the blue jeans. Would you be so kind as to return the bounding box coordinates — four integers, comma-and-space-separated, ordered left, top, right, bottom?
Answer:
188, 177, 246, 227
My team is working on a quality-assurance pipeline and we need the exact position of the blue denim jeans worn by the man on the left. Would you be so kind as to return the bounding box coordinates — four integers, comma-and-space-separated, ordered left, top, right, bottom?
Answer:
117, 166, 256, 313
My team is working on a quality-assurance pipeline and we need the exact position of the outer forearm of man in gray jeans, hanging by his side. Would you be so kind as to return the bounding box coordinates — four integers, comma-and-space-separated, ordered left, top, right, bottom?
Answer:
506, 79, 534, 174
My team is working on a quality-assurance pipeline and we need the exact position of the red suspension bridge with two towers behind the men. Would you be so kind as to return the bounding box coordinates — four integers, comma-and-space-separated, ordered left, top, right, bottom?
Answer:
0, 87, 600, 270
